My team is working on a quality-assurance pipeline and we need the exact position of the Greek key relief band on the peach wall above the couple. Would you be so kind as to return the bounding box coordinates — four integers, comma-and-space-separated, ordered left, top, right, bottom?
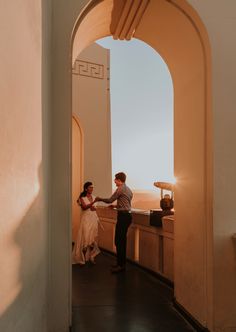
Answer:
72, 60, 104, 79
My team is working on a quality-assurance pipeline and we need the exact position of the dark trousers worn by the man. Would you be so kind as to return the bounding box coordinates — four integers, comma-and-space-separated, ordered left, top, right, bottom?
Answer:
115, 211, 132, 267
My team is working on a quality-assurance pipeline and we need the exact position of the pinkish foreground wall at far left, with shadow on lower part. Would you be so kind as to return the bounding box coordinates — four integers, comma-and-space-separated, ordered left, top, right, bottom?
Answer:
0, 0, 49, 332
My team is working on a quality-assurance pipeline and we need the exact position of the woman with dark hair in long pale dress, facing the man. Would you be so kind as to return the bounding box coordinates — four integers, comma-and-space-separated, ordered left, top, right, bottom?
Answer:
72, 182, 100, 264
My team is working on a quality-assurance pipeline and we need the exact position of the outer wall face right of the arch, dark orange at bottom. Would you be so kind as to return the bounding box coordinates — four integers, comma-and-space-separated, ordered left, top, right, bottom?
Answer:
189, 0, 236, 332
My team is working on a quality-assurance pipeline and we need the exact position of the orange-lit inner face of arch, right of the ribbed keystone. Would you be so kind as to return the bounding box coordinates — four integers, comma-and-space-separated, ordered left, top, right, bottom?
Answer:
135, 1, 211, 326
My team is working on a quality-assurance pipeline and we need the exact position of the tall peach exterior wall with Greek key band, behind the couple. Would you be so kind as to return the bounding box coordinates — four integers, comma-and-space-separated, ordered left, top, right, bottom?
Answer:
72, 43, 112, 197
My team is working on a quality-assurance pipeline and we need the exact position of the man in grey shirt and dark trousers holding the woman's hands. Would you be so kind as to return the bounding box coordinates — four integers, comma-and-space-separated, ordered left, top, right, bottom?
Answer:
95, 172, 133, 273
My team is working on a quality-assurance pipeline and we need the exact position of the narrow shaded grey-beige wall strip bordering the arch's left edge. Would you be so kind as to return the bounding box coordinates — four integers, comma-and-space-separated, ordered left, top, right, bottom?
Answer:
48, 0, 88, 332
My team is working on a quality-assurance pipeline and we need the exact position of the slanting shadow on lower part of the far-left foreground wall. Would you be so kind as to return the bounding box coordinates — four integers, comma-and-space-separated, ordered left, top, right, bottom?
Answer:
0, 167, 47, 332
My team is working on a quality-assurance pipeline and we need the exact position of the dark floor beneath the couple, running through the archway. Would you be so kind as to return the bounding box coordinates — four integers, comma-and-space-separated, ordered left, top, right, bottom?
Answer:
72, 253, 194, 332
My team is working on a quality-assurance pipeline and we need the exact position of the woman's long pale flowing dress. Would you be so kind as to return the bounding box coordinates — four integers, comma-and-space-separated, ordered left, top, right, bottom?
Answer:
72, 196, 100, 264
